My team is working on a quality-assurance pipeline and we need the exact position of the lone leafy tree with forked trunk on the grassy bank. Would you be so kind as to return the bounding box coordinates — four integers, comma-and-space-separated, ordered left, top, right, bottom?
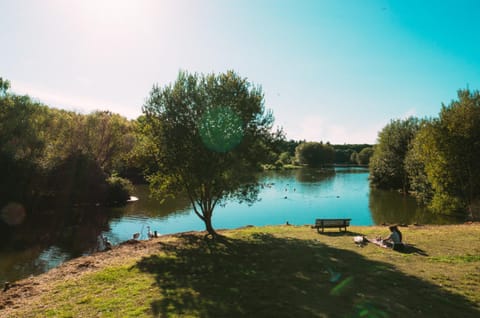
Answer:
143, 71, 273, 237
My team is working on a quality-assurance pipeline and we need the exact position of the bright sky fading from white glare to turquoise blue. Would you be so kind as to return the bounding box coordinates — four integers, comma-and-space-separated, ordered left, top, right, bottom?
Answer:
0, 0, 480, 144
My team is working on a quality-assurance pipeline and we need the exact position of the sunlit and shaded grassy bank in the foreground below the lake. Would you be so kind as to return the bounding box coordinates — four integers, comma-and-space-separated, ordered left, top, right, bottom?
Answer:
0, 224, 480, 317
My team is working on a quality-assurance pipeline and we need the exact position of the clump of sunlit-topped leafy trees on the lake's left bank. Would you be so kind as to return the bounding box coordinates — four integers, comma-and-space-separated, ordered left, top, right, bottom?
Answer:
0, 78, 133, 208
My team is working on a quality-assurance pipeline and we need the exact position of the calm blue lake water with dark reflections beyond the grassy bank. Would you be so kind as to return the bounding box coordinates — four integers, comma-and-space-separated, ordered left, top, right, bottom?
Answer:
0, 168, 456, 284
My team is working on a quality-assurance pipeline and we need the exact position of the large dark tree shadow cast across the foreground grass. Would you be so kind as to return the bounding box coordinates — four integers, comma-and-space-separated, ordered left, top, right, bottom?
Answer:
136, 234, 480, 317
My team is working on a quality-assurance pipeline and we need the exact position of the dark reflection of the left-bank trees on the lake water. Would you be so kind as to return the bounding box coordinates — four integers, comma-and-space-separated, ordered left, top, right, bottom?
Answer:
0, 207, 109, 283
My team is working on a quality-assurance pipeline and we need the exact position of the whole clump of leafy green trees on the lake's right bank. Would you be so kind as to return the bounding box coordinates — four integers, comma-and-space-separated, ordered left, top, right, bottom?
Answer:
370, 90, 480, 218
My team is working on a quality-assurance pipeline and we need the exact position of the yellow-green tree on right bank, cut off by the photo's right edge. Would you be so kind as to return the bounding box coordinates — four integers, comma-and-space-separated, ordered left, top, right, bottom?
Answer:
409, 90, 480, 215
